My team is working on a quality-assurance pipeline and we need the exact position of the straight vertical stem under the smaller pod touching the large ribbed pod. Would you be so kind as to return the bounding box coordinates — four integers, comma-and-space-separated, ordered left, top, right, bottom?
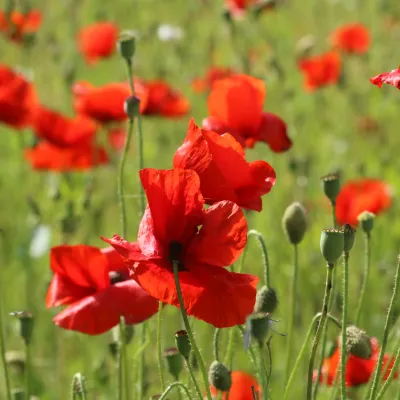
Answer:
340, 251, 349, 400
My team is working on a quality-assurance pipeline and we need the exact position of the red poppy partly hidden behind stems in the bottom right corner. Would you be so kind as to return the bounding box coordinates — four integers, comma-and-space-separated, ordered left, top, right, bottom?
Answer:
314, 338, 395, 386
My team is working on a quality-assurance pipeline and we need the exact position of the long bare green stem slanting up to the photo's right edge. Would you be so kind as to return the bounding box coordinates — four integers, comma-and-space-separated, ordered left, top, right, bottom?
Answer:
369, 257, 400, 400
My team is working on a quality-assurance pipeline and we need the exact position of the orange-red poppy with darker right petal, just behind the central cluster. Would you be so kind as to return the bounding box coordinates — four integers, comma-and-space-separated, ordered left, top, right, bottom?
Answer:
203, 75, 292, 152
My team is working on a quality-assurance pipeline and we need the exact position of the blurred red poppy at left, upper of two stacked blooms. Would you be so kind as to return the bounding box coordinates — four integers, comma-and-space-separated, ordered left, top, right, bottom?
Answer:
32, 107, 97, 147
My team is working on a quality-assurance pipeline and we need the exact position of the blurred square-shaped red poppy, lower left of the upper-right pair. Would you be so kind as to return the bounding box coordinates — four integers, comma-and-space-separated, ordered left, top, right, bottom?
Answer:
299, 51, 342, 92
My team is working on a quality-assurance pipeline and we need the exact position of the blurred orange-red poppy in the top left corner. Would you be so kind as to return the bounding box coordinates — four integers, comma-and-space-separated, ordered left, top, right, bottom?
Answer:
0, 10, 42, 42
